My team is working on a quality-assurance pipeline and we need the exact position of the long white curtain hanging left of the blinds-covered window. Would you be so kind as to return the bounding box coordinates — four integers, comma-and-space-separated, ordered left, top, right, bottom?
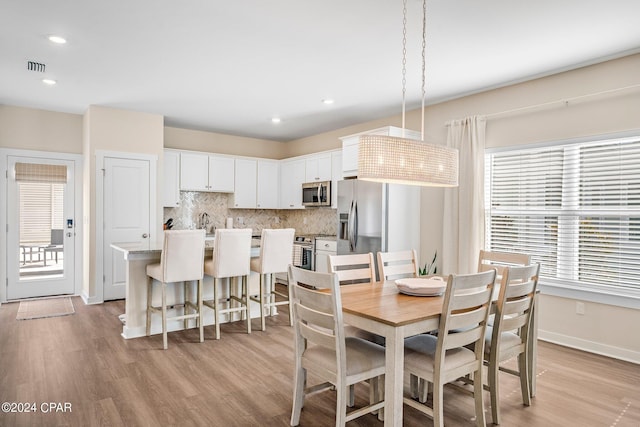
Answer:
442, 116, 486, 274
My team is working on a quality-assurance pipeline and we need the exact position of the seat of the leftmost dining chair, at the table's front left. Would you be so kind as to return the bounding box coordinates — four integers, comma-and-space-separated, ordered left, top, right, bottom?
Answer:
302, 337, 384, 376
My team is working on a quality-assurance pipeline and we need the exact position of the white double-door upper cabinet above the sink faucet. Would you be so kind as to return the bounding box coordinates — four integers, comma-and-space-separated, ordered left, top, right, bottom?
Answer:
180, 153, 235, 193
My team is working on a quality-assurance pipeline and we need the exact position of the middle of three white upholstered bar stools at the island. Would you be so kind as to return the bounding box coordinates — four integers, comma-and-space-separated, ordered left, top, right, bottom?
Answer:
200, 228, 252, 340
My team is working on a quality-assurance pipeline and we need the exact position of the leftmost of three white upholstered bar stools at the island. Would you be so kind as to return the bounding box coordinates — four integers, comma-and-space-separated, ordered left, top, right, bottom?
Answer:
146, 230, 205, 350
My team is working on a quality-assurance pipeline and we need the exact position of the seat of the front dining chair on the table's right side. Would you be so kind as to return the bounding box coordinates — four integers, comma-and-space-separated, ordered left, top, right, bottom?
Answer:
404, 334, 476, 378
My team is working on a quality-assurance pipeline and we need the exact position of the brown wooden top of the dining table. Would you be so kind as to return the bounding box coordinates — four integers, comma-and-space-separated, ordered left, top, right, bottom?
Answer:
340, 281, 444, 327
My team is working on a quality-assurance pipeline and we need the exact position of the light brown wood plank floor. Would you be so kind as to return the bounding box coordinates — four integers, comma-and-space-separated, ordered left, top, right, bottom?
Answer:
0, 298, 640, 427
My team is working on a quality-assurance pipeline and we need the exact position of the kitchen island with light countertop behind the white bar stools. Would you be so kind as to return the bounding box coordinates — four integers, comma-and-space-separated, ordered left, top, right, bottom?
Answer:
111, 239, 262, 339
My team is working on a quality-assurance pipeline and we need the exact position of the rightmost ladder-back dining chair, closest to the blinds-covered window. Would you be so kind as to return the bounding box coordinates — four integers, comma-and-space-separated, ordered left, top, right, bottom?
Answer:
484, 264, 540, 424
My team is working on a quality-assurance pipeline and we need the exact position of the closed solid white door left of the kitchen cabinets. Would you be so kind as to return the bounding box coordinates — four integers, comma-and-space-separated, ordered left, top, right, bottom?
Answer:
102, 157, 151, 301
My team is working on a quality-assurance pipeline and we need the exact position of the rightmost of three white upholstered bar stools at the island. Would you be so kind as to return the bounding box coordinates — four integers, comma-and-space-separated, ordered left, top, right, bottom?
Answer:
250, 228, 296, 331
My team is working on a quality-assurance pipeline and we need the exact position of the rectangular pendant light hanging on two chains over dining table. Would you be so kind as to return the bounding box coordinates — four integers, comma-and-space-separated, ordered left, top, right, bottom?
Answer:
358, 0, 458, 187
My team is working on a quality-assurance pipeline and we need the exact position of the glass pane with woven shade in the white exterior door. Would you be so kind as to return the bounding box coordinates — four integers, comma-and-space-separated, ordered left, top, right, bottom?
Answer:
16, 163, 67, 282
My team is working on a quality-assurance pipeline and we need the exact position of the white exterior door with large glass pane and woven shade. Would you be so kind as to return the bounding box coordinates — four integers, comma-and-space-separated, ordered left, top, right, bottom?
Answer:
6, 156, 76, 300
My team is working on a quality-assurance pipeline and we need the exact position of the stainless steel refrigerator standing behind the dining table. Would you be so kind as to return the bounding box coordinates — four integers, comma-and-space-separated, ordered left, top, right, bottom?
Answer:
337, 179, 420, 280
